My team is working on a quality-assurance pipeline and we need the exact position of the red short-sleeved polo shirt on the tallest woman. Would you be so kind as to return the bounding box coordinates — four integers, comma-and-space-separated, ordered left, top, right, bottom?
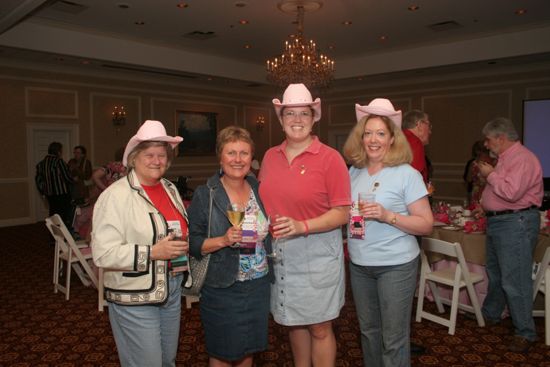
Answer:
259, 136, 351, 220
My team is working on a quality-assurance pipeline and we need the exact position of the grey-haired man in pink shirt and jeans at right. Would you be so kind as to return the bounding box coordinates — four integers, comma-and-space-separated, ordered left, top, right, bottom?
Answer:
476, 117, 544, 352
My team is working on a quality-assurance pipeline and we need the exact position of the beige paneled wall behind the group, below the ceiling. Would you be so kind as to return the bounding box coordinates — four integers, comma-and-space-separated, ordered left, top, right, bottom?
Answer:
0, 61, 550, 226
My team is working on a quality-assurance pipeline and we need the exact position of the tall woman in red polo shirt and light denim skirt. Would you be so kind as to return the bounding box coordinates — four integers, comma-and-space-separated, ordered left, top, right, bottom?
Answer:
259, 84, 351, 367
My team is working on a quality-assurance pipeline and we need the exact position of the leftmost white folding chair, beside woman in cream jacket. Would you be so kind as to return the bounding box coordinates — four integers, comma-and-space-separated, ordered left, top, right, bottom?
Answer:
46, 214, 98, 300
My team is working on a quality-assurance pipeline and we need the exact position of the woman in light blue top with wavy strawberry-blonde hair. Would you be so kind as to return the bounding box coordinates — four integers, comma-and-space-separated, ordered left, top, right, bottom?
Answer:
344, 98, 433, 367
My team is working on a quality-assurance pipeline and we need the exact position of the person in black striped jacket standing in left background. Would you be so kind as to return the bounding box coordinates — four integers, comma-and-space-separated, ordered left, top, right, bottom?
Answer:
35, 142, 73, 232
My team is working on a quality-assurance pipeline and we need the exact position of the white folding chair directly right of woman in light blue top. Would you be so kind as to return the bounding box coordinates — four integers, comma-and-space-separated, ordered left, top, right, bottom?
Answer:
416, 238, 485, 335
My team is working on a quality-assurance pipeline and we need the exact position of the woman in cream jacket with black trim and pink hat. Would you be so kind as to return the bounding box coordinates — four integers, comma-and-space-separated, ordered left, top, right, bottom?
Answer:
92, 120, 189, 367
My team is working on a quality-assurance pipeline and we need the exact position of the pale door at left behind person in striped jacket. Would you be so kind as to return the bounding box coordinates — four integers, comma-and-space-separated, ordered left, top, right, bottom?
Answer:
27, 124, 78, 222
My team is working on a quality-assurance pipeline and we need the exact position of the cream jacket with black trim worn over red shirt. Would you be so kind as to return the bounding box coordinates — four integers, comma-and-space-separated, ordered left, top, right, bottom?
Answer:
91, 170, 187, 305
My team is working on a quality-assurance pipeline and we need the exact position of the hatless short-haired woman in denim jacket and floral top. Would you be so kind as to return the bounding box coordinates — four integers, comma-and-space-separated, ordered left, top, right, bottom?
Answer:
188, 126, 273, 367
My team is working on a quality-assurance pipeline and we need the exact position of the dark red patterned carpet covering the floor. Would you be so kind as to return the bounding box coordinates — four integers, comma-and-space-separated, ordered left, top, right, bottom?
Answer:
0, 223, 550, 367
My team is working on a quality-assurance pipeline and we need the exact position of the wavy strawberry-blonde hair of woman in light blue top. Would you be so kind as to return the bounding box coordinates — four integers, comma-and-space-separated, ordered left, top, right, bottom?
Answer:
343, 115, 412, 168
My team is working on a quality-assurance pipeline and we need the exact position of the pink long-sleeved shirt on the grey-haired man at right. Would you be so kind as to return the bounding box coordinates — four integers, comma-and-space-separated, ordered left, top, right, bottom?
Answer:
481, 142, 544, 211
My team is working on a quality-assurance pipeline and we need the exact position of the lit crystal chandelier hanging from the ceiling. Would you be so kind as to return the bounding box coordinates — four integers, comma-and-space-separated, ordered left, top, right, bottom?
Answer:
266, 1, 334, 88
